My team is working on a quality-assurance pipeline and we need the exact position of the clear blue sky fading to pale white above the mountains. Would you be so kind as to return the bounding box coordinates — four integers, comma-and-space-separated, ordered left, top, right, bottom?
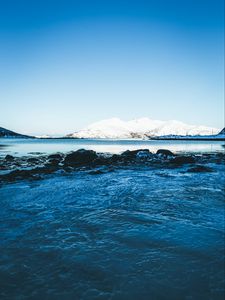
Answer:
0, 0, 224, 135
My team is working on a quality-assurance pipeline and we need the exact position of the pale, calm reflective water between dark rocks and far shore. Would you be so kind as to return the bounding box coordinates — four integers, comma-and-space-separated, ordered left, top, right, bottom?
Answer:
0, 138, 225, 156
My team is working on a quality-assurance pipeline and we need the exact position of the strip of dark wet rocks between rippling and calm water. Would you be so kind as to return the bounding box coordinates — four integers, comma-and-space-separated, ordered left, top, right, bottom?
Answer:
0, 149, 225, 184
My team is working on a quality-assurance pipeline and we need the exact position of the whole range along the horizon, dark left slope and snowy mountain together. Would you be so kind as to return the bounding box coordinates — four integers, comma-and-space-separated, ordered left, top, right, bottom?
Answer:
0, 118, 225, 139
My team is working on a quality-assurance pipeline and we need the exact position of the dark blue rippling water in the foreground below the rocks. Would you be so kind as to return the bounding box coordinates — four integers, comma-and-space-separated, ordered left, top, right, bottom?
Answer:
0, 165, 224, 300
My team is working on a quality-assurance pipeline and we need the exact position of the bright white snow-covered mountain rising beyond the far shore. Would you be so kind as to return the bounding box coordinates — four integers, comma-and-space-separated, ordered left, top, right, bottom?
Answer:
67, 118, 219, 139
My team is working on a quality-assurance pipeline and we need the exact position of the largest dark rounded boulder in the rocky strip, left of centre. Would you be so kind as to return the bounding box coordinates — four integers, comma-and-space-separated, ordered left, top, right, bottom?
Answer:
64, 149, 98, 166
